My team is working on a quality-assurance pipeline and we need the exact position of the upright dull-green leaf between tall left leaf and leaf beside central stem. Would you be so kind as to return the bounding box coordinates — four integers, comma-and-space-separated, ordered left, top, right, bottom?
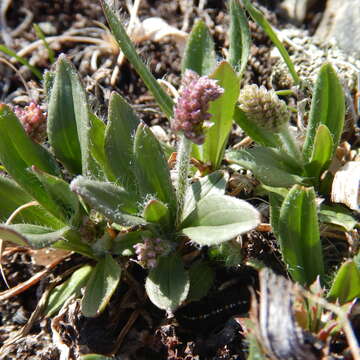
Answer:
105, 92, 140, 191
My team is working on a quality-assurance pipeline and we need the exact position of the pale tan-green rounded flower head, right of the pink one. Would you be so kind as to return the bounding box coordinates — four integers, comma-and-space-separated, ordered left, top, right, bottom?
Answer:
239, 84, 290, 132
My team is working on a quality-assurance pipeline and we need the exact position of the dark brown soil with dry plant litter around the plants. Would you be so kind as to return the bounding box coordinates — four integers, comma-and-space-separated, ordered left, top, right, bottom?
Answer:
0, 0, 358, 360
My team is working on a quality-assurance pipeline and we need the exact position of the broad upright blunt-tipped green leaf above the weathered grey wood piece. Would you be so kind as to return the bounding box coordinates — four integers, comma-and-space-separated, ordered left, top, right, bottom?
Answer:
278, 185, 324, 285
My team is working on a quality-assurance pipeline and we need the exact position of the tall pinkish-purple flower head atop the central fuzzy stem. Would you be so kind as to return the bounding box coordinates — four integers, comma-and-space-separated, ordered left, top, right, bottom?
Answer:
171, 70, 224, 145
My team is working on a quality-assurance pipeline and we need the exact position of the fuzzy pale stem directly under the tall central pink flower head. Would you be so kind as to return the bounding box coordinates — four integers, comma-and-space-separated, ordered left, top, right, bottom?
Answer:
175, 134, 192, 226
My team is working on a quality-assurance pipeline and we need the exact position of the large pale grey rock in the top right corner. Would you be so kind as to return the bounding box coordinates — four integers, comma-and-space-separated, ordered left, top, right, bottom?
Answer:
315, 0, 360, 56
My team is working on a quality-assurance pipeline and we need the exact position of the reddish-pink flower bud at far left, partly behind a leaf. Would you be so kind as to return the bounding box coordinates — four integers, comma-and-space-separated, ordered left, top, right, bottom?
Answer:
14, 101, 46, 143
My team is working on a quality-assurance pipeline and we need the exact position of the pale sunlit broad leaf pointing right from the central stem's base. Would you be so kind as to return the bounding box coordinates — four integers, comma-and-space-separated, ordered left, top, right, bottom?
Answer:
181, 195, 260, 246
